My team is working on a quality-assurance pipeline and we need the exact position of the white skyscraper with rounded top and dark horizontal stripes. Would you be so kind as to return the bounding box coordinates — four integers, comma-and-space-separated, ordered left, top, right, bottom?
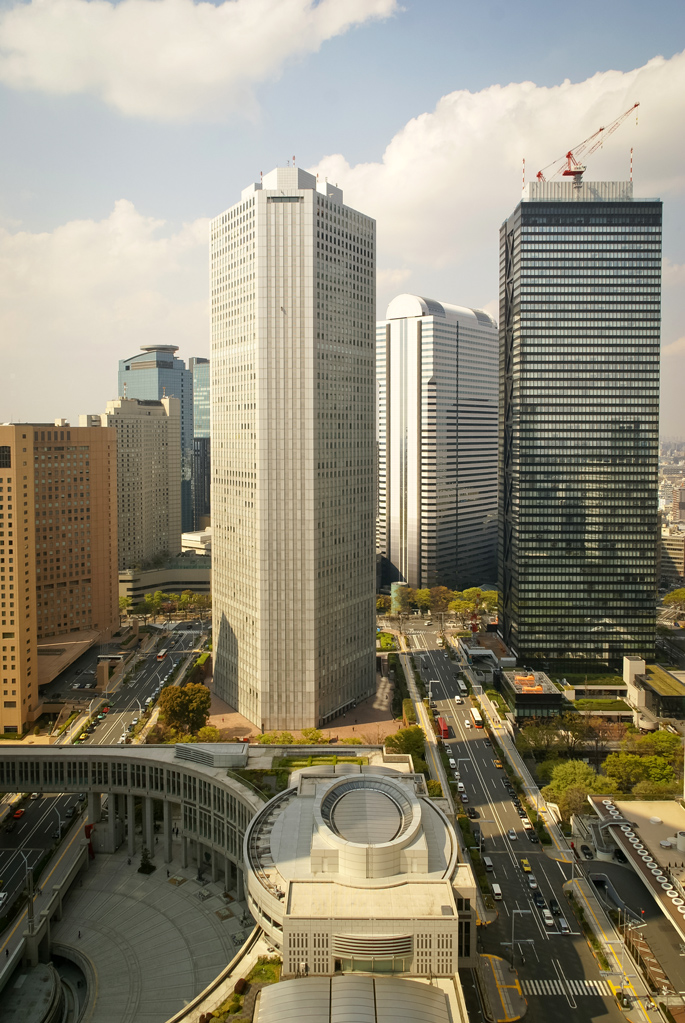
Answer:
376, 295, 499, 589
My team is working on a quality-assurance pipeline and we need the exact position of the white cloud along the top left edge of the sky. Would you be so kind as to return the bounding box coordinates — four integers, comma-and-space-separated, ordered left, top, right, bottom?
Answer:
0, 0, 397, 121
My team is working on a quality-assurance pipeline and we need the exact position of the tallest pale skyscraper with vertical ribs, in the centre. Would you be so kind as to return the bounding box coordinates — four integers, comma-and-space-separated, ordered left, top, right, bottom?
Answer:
211, 167, 375, 730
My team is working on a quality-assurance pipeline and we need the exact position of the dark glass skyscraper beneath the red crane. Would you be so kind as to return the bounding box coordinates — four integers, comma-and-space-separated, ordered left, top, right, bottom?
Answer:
499, 181, 661, 663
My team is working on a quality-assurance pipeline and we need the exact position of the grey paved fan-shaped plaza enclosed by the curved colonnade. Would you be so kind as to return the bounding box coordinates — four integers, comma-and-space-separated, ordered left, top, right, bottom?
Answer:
52, 843, 254, 1023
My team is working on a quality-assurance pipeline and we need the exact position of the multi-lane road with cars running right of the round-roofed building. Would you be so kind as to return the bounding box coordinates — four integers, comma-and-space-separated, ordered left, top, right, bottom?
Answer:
407, 629, 622, 1021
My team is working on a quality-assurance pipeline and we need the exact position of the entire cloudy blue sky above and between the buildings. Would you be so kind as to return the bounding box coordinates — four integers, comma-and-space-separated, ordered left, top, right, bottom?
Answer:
0, 0, 685, 438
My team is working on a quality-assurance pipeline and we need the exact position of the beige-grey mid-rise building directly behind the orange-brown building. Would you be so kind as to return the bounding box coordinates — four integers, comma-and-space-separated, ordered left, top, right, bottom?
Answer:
80, 398, 181, 572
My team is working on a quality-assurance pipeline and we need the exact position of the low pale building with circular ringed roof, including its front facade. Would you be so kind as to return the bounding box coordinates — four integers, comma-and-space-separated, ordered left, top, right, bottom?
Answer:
244, 757, 475, 977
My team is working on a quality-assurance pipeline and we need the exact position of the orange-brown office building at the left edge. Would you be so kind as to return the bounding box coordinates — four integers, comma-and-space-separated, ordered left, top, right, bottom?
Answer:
0, 420, 119, 735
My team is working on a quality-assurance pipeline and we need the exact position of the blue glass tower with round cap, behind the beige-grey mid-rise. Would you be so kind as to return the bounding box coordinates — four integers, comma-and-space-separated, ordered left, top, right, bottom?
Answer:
119, 345, 194, 532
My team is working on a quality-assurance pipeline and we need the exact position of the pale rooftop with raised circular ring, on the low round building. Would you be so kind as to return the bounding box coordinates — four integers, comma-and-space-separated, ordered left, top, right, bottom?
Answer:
245, 763, 468, 919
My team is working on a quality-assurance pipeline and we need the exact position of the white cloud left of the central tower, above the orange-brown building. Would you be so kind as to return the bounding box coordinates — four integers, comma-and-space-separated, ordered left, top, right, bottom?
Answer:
0, 201, 209, 421
